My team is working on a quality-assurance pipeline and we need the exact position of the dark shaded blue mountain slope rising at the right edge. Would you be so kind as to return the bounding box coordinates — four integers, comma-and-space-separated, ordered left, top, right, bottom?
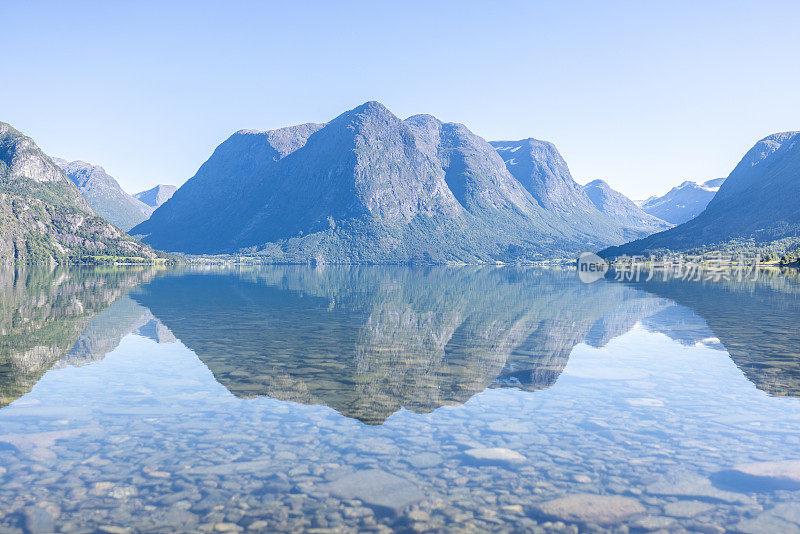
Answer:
602, 132, 800, 256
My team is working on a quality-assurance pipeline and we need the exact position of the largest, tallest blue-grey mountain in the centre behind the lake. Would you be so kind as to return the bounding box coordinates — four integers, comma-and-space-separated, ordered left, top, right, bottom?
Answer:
132, 102, 641, 263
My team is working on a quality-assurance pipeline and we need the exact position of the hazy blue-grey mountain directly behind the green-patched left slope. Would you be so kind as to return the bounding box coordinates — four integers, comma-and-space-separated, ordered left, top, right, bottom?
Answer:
53, 158, 153, 232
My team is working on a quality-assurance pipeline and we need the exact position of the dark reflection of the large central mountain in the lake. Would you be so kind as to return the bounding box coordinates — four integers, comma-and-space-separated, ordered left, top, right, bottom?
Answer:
132, 267, 666, 424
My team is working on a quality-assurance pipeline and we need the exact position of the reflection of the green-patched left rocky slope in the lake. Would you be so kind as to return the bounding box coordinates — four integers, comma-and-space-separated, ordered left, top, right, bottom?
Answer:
0, 268, 163, 406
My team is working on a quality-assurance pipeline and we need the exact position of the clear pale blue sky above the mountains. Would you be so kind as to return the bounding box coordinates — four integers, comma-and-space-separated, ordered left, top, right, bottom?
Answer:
0, 0, 800, 198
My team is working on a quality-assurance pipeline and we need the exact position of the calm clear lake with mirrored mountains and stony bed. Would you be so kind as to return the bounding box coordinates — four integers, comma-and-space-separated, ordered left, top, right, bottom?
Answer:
0, 266, 800, 533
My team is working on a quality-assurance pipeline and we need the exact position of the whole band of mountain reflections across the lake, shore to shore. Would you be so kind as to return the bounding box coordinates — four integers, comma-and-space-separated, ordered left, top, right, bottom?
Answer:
0, 266, 800, 425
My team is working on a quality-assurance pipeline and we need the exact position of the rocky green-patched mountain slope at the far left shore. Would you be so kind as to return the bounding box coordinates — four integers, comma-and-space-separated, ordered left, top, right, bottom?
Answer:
0, 122, 156, 264
